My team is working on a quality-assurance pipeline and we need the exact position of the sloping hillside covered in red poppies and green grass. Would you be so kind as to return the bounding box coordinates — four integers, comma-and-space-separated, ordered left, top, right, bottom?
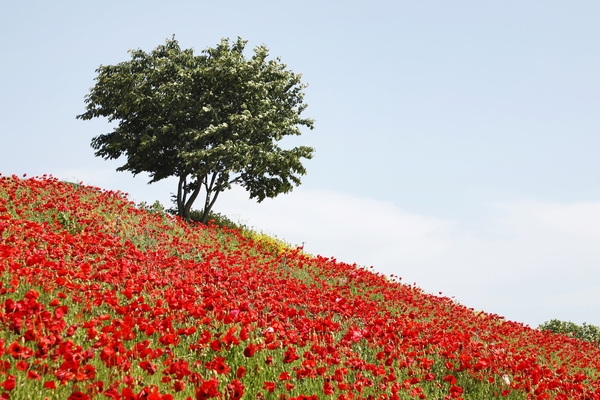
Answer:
0, 176, 600, 399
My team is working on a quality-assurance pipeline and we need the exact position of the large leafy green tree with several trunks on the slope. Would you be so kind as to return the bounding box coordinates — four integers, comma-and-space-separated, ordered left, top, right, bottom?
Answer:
77, 37, 314, 223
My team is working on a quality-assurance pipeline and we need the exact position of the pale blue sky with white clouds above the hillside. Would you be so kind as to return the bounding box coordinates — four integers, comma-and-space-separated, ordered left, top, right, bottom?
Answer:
0, 0, 600, 326
